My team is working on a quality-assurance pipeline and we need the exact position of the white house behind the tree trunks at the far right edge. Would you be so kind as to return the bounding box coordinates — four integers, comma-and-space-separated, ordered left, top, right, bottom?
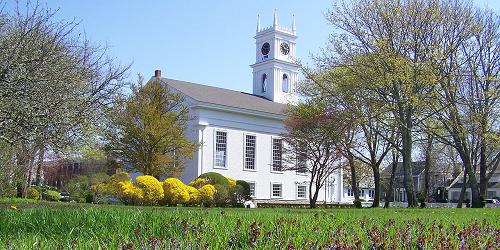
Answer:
448, 171, 500, 202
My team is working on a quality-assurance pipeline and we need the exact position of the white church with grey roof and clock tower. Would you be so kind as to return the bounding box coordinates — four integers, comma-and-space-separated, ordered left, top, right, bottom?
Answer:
153, 13, 343, 202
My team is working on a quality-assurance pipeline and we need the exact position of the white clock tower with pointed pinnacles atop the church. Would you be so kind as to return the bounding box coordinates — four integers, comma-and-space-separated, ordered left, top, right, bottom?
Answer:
250, 10, 299, 103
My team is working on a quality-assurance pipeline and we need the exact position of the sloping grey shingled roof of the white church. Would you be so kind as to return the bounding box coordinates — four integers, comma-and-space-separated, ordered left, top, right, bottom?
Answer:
160, 78, 287, 116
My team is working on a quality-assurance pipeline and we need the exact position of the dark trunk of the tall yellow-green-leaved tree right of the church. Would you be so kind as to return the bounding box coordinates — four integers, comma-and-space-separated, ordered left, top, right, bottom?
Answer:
401, 123, 418, 207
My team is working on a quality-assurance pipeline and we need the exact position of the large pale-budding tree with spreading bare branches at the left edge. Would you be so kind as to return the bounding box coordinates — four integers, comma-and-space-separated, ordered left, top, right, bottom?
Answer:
0, 2, 128, 193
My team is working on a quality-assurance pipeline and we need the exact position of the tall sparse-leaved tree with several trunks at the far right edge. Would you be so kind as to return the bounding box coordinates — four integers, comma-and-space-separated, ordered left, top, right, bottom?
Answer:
425, 1, 500, 207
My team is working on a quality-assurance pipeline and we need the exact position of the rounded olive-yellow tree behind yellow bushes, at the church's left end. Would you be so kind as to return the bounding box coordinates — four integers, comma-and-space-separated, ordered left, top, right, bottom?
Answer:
108, 79, 198, 179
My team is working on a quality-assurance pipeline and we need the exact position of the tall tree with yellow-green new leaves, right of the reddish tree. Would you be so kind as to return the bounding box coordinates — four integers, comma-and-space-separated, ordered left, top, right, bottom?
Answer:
318, 0, 488, 207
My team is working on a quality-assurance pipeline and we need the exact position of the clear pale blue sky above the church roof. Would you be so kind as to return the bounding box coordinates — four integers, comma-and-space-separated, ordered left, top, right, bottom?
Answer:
6, 0, 500, 92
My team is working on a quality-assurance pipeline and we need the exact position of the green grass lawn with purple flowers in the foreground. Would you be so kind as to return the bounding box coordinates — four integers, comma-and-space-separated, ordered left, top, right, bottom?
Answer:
0, 200, 500, 249
